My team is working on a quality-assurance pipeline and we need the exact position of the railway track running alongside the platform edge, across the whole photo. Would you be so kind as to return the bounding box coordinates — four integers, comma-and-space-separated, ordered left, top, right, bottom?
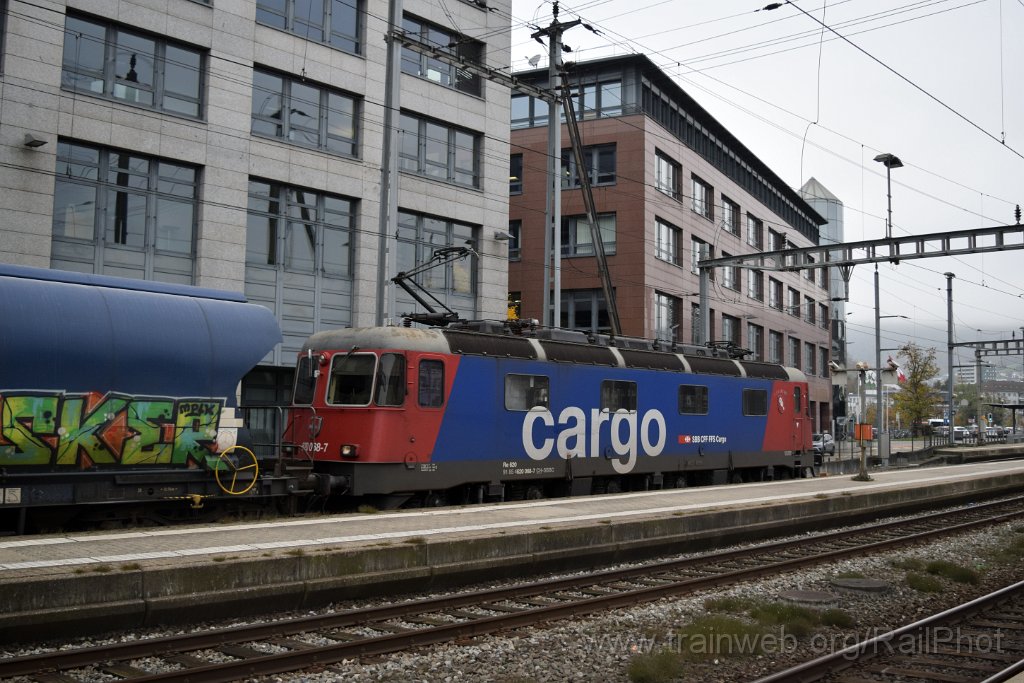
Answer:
6, 497, 1024, 682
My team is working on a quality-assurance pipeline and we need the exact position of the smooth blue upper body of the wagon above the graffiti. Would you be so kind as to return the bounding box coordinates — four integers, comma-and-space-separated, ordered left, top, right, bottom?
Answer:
0, 264, 282, 405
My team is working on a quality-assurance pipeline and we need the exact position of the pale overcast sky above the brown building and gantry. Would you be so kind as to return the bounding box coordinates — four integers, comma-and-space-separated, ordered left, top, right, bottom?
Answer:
503, 0, 1024, 375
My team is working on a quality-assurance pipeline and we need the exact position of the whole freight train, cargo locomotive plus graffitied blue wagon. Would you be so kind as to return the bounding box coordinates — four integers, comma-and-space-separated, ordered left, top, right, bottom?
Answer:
0, 266, 813, 532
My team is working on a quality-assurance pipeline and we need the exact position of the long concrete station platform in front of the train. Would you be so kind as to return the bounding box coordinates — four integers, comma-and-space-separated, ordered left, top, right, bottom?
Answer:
0, 460, 1024, 642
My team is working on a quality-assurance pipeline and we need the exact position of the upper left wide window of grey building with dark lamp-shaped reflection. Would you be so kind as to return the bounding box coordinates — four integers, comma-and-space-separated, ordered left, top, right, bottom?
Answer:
60, 14, 204, 118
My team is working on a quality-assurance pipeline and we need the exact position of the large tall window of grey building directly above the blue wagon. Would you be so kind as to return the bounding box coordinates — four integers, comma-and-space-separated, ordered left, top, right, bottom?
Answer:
50, 140, 199, 284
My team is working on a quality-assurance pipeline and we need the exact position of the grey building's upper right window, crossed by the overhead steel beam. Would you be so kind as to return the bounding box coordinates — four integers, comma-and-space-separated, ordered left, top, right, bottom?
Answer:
401, 14, 483, 96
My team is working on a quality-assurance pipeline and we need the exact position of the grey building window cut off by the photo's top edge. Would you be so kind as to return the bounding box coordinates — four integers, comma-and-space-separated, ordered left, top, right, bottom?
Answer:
256, 0, 362, 54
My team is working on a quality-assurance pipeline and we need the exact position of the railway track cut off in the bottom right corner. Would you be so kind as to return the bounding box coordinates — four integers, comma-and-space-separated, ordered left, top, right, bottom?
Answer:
755, 582, 1024, 683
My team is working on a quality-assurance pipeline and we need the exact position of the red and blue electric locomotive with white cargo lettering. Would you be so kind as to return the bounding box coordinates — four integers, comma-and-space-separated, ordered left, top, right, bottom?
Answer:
286, 323, 813, 507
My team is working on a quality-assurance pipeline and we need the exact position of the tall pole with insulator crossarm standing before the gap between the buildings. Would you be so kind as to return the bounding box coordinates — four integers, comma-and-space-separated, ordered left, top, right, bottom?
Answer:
531, 0, 583, 328
